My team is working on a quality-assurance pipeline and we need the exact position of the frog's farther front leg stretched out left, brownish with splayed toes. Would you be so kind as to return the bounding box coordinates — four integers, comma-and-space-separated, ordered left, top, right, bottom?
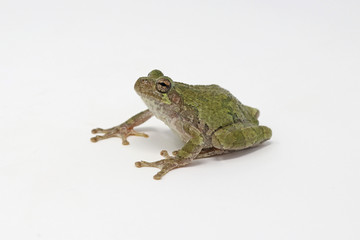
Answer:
91, 110, 153, 145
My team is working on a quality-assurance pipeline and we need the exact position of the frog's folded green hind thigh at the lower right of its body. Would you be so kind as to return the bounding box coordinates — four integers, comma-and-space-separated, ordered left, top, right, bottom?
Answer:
212, 123, 271, 150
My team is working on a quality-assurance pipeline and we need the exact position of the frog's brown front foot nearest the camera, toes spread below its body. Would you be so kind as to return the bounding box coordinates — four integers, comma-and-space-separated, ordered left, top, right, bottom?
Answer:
135, 150, 191, 180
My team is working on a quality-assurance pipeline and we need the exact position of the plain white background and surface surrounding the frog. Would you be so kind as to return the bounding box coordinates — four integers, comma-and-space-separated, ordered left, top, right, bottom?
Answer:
0, 0, 360, 240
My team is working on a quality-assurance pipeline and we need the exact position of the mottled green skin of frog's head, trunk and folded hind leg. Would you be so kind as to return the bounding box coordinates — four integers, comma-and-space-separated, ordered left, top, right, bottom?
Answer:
135, 70, 271, 153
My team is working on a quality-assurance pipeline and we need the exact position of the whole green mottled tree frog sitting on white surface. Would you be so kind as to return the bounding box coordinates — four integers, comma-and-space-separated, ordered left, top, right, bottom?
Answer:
91, 69, 272, 180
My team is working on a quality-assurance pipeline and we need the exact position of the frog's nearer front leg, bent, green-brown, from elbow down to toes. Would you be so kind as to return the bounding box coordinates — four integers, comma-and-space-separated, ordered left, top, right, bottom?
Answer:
135, 124, 204, 180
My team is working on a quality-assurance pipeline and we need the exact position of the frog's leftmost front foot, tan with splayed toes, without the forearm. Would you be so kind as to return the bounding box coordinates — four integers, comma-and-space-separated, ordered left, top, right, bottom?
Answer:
90, 125, 149, 145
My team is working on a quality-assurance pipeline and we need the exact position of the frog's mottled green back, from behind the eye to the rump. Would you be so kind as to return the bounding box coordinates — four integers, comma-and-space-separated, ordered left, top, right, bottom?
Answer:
175, 82, 258, 130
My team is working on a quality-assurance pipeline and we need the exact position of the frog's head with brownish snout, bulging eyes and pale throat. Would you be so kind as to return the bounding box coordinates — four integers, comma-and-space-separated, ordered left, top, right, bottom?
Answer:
134, 70, 180, 109
